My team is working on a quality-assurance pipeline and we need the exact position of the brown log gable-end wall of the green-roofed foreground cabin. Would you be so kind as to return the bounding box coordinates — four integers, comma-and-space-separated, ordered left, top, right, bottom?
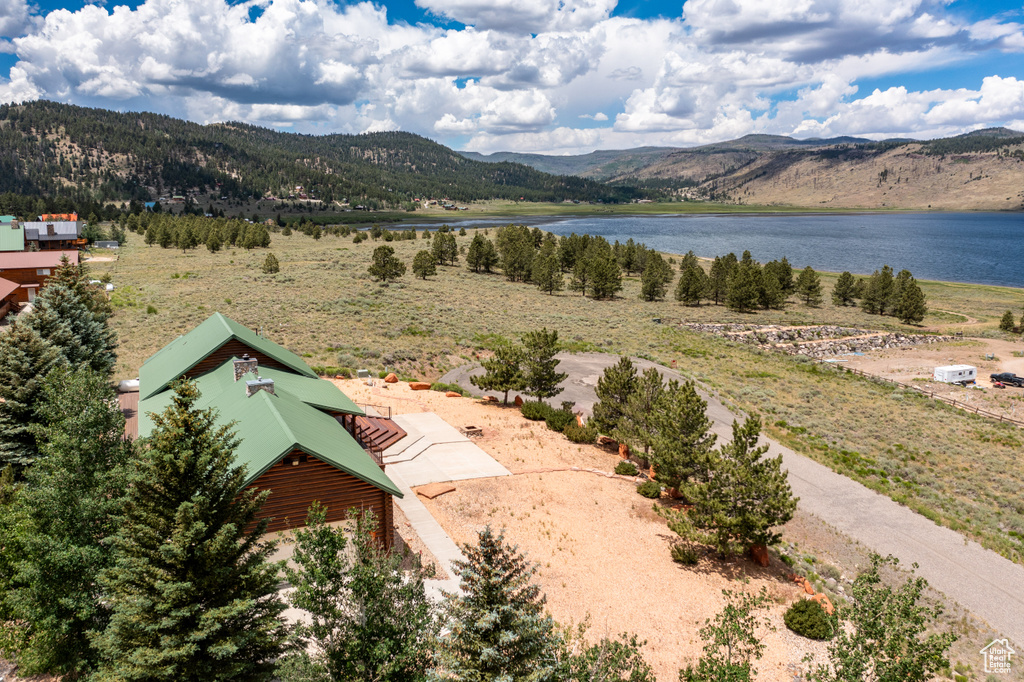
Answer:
250, 450, 394, 549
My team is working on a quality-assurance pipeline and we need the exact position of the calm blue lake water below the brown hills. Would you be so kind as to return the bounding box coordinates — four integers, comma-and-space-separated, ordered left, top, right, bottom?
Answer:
411, 213, 1024, 287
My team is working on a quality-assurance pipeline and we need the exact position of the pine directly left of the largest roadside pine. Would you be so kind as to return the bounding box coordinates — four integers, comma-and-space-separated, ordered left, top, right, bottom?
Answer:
650, 381, 716, 489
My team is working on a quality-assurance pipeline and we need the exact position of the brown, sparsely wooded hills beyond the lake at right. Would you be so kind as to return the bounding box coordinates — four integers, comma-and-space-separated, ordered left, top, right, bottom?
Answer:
464, 128, 1024, 210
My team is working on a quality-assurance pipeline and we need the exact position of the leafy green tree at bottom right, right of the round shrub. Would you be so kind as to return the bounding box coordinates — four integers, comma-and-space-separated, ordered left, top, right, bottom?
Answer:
809, 554, 956, 682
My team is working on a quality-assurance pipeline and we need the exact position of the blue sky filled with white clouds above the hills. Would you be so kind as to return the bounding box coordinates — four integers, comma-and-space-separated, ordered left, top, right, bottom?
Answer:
0, 0, 1024, 154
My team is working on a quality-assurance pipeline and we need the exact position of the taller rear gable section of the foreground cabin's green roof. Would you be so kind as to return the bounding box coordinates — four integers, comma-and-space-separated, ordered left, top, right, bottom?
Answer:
138, 312, 316, 400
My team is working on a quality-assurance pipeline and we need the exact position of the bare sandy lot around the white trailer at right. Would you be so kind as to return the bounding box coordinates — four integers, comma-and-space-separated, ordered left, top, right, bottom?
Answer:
839, 339, 1024, 421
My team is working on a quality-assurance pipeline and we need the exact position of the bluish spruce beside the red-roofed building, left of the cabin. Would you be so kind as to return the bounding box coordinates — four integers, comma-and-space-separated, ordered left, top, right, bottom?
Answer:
26, 283, 117, 374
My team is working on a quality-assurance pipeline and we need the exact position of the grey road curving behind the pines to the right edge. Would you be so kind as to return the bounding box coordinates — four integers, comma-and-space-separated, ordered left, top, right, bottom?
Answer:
441, 353, 1024, 644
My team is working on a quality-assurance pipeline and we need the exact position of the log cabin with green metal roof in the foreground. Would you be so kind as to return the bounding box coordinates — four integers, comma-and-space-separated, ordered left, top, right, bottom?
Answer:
135, 312, 404, 546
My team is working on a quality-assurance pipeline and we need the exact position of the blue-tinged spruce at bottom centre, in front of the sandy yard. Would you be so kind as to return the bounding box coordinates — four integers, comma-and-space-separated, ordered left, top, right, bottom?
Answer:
432, 525, 558, 682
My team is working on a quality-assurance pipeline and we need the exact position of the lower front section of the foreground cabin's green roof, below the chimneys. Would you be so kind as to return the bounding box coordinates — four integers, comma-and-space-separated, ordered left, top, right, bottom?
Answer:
138, 360, 401, 497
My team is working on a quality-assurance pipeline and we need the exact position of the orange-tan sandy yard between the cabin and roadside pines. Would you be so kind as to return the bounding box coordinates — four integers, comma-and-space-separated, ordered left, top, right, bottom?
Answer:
336, 380, 824, 682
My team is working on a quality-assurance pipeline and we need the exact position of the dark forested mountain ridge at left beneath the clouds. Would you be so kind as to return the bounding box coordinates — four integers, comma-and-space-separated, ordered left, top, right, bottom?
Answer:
0, 101, 641, 208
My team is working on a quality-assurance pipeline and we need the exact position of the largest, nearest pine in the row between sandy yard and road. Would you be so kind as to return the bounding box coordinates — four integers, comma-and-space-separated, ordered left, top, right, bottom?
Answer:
667, 417, 797, 556
